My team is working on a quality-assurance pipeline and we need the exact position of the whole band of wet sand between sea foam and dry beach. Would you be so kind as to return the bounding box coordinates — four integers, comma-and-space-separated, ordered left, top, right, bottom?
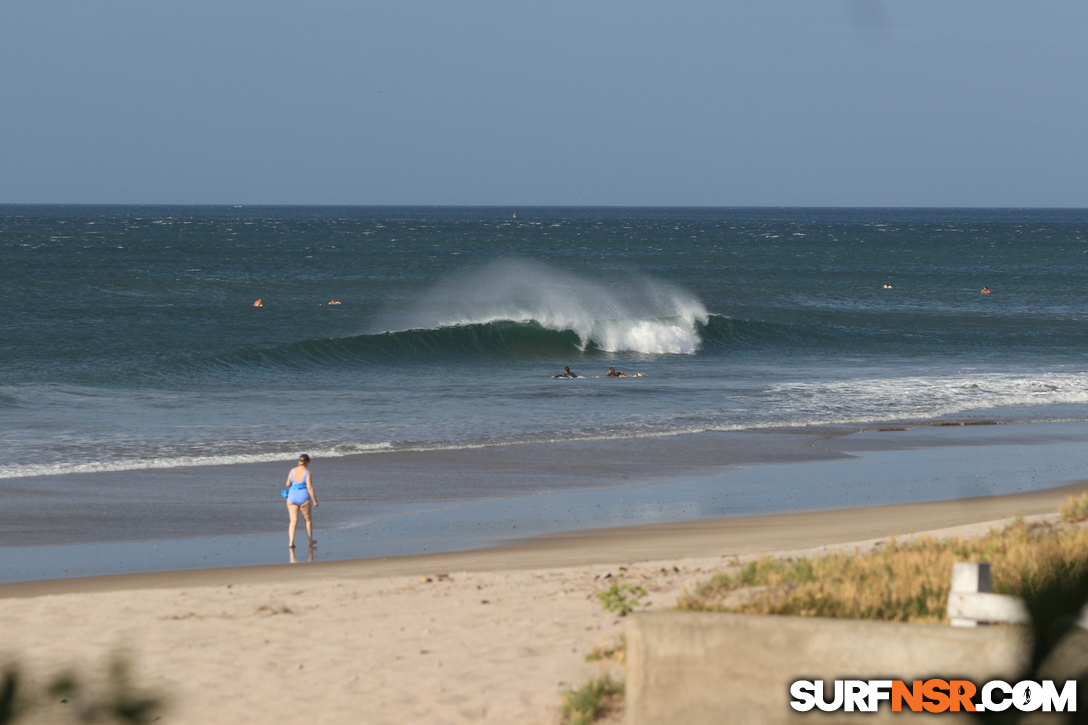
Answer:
6, 421, 1088, 583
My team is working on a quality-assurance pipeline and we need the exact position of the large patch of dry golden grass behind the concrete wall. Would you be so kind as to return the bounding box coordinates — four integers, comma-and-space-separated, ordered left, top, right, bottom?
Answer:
677, 513, 1088, 623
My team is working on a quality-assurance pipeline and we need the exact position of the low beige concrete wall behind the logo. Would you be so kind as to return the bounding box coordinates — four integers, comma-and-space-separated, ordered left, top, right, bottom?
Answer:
627, 612, 1027, 725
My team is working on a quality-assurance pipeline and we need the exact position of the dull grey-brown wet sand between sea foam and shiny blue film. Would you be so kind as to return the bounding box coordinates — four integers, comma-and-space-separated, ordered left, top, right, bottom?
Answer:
0, 431, 848, 546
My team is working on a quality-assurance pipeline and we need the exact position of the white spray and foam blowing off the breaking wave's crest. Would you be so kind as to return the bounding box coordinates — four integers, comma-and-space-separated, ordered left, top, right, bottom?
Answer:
387, 259, 709, 355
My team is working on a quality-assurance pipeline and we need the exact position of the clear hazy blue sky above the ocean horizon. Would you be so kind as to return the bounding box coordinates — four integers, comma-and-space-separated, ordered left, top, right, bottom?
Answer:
0, 0, 1088, 207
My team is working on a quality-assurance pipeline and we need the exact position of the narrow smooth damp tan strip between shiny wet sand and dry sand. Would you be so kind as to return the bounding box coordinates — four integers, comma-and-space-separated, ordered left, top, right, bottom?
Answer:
0, 480, 1088, 599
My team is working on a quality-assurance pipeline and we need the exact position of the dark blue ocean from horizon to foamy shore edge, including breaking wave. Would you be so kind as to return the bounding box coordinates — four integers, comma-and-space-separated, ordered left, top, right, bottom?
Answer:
0, 206, 1088, 478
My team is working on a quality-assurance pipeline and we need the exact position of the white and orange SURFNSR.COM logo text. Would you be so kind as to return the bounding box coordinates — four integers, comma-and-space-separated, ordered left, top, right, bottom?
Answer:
790, 679, 1077, 713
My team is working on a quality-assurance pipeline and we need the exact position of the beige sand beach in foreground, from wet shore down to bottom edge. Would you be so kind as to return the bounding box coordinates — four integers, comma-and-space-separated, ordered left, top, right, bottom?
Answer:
0, 478, 1086, 724
